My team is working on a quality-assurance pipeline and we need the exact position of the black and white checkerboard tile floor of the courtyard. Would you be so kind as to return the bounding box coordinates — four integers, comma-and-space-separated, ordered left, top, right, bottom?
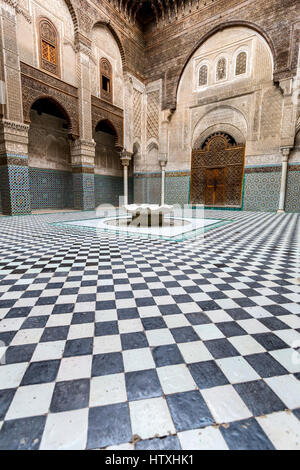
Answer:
0, 211, 300, 450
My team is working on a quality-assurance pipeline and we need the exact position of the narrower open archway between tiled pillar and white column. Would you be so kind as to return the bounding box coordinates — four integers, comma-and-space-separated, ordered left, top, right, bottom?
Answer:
94, 119, 124, 207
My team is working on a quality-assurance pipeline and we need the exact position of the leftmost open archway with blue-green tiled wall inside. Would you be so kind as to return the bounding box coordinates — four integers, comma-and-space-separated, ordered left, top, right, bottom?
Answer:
28, 98, 74, 210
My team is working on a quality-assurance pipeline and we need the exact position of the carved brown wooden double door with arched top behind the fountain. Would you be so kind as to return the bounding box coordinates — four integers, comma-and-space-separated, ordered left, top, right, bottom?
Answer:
190, 132, 245, 207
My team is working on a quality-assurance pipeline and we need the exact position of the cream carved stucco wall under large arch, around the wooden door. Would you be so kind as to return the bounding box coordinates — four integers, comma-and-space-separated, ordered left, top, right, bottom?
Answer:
168, 27, 283, 170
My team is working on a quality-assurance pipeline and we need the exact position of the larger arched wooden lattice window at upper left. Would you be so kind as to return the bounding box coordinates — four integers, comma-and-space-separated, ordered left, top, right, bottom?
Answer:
39, 18, 59, 75
